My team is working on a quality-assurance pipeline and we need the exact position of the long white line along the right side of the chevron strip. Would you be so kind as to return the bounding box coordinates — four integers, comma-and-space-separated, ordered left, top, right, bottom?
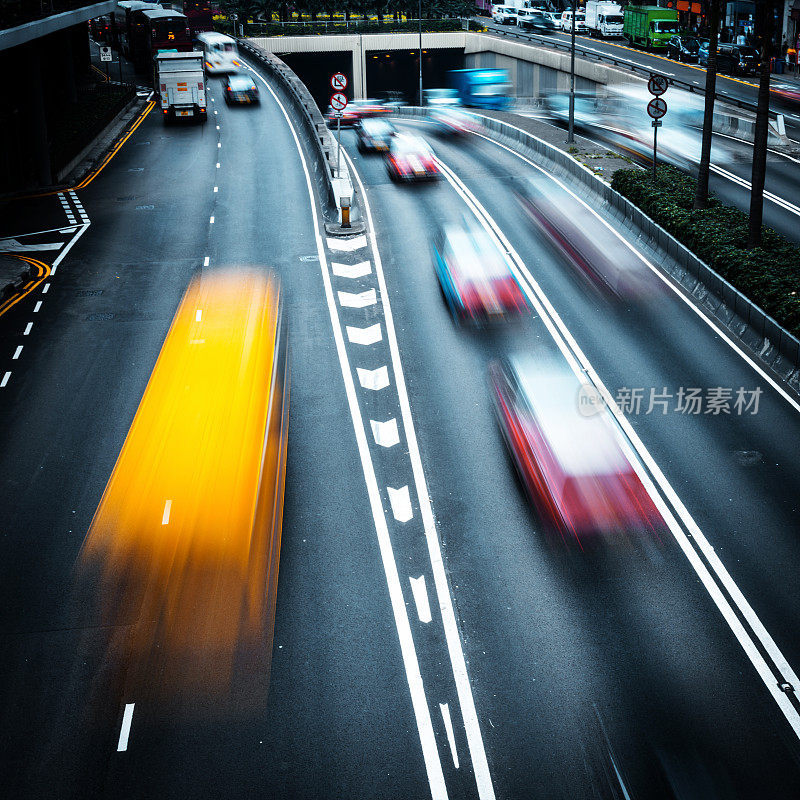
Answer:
342, 145, 495, 800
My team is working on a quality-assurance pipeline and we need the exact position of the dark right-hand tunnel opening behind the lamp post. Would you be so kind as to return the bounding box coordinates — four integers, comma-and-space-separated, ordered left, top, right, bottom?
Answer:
365, 47, 464, 103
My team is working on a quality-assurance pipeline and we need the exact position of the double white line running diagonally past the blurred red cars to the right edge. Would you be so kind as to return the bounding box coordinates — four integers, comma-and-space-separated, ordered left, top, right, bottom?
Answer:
437, 153, 800, 737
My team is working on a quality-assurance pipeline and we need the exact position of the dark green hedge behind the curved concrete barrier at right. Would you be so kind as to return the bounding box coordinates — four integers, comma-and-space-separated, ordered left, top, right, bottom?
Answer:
611, 165, 800, 337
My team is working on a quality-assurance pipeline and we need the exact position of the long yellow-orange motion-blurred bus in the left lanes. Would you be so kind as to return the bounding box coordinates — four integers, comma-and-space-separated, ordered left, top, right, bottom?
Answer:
83, 271, 289, 690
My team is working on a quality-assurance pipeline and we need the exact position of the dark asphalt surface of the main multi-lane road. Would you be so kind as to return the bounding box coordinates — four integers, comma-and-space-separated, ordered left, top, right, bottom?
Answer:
0, 56, 800, 799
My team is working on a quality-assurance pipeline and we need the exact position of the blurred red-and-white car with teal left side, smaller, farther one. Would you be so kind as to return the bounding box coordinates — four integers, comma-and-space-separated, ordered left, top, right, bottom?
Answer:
433, 220, 528, 321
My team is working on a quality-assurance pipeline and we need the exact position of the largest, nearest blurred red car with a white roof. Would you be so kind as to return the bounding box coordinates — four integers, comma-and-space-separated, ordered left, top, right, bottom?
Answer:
489, 357, 661, 543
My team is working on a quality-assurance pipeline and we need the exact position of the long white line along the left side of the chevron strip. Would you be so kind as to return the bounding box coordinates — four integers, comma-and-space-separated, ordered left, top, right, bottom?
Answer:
253, 64, 447, 800
